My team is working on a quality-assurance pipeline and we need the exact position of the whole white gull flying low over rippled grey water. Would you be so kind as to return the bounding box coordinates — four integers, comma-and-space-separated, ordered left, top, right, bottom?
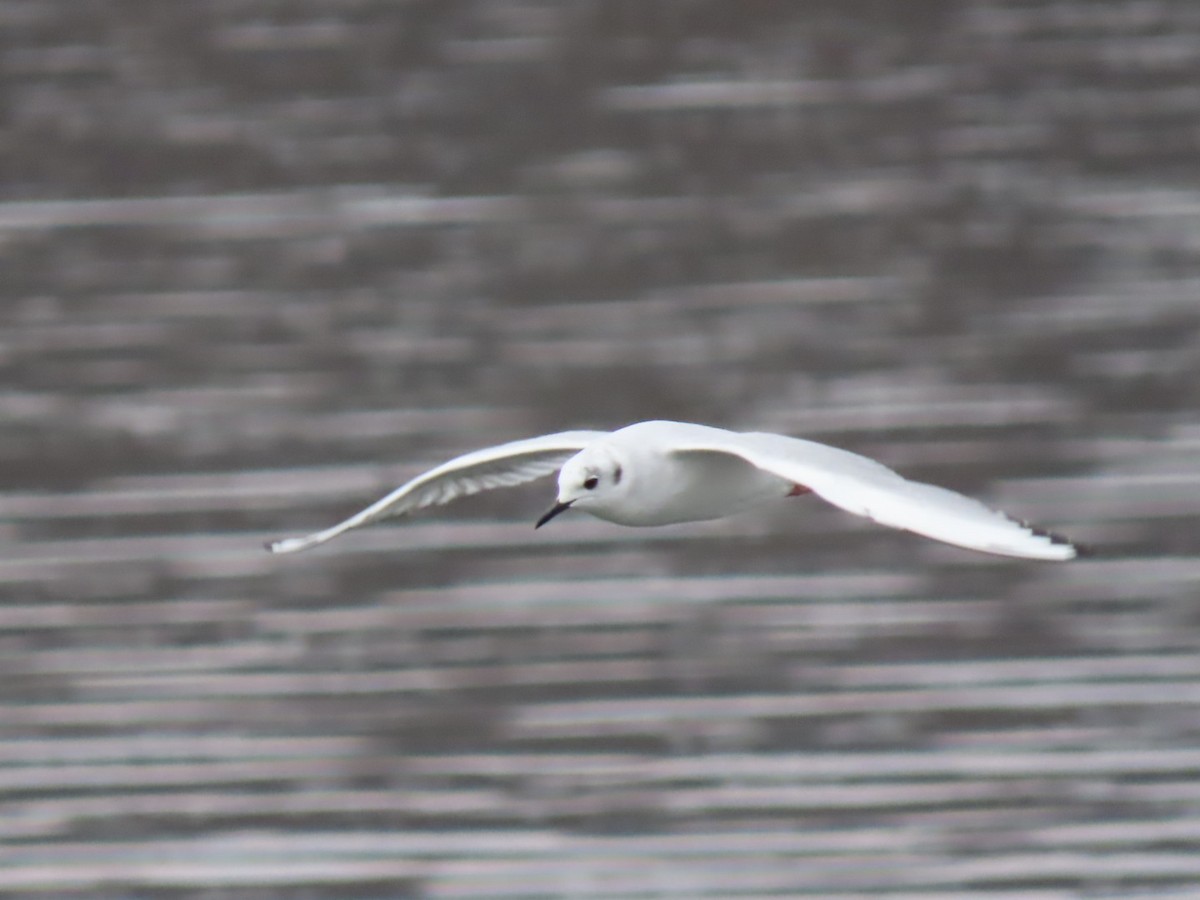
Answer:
266, 421, 1081, 560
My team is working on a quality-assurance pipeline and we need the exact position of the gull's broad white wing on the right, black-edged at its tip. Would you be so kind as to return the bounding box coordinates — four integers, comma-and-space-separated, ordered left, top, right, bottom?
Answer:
676, 432, 1078, 559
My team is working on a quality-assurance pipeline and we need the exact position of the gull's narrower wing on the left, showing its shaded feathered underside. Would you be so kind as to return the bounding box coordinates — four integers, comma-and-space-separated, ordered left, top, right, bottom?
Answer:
266, 431, 608, 553
